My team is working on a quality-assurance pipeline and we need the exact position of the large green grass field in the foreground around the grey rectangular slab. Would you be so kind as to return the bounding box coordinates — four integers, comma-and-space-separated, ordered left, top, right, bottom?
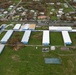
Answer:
0, 46, 76, 75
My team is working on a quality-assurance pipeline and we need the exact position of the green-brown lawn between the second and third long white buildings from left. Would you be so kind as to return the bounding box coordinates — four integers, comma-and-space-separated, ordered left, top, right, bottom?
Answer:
29, 32, 42, 45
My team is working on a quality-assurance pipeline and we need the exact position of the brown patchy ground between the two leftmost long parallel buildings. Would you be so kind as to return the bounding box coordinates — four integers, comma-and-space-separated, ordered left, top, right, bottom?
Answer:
7, 32, 24, 50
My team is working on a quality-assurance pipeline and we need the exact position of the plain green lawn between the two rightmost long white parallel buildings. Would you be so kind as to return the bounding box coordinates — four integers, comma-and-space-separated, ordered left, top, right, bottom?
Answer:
50, 32, 64, 45
